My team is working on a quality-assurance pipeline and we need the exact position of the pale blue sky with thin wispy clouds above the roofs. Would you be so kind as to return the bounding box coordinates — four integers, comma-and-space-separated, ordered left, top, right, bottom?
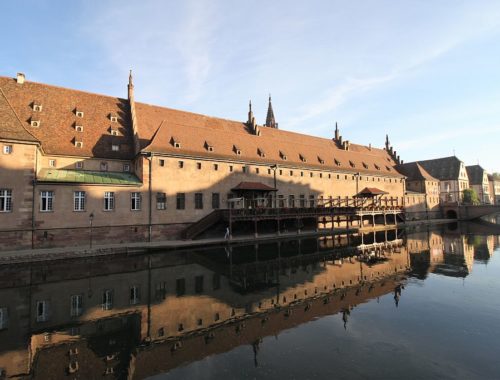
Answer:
0, 0, 500, 172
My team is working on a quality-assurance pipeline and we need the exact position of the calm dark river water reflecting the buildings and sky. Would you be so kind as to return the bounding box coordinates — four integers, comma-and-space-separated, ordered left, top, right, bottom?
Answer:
0, 225, 500, 379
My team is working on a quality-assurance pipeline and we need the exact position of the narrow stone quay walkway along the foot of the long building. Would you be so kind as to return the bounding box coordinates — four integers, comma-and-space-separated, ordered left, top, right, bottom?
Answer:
0, 219, 454, 265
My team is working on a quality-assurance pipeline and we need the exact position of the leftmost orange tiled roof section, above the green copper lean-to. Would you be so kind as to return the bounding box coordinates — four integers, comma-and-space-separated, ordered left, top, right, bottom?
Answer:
0, 77, 134, 159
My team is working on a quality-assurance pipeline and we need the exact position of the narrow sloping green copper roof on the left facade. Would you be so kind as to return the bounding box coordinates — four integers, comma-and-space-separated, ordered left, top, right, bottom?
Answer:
38, 169, 141, 185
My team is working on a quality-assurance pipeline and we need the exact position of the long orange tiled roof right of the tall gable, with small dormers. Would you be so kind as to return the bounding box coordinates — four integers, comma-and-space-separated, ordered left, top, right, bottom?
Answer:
135, 103, 401, 177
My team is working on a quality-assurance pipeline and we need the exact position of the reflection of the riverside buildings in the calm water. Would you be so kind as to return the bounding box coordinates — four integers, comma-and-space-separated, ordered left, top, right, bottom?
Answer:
0, 227, 494, 379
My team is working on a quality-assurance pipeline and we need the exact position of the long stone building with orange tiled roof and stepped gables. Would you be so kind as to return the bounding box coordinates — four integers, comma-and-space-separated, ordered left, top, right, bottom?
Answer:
0, 74, 405, 249
